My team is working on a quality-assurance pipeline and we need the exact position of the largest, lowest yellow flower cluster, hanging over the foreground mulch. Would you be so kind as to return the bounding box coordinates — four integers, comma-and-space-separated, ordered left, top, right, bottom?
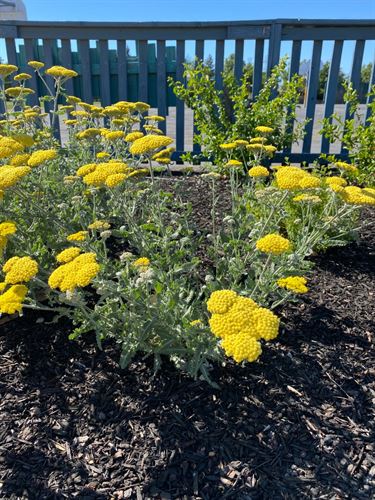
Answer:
207, 290, 280, 363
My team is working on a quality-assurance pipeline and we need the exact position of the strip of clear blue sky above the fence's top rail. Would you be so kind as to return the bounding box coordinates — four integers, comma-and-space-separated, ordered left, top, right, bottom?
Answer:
24, 0, 375, 21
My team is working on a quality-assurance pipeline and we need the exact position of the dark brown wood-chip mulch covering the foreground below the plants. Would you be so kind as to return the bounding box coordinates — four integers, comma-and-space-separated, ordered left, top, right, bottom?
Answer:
0, 181, 375, 500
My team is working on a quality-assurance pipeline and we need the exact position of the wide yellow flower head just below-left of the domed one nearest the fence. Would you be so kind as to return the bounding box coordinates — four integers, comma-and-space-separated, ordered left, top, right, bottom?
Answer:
77, 161, 132, 187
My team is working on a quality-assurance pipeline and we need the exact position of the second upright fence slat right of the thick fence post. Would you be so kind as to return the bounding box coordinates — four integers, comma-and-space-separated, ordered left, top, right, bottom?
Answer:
302, 40, 322, 153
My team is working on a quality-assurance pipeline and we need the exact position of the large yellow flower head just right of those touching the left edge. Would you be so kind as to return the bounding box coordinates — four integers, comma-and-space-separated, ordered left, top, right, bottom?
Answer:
48, 252, 100, 292
